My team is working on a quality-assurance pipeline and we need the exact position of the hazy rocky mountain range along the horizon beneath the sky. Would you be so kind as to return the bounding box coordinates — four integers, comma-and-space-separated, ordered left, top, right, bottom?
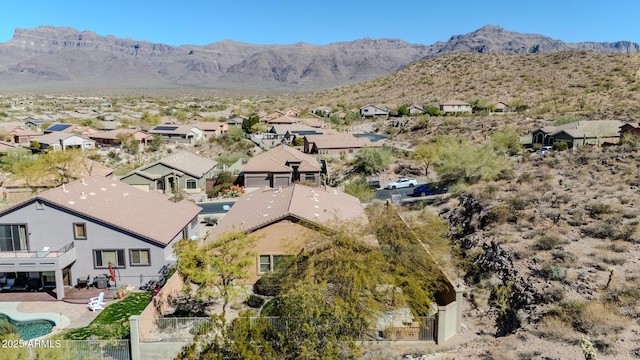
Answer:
0, 25, 640, 91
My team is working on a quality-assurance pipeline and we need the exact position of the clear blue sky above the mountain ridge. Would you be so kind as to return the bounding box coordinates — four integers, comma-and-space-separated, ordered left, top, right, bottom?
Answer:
0, 0, 640, 45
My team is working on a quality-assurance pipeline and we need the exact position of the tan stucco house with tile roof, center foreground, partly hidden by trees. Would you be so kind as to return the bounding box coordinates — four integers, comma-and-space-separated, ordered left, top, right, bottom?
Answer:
205, 184, 368, 283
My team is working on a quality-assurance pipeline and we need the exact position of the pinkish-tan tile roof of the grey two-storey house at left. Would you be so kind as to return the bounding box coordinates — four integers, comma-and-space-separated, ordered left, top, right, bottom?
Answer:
36, 176, 200, 245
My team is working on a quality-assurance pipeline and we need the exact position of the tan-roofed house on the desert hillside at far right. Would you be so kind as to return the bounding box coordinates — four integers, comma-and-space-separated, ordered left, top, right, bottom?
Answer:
531, 120, 623, 149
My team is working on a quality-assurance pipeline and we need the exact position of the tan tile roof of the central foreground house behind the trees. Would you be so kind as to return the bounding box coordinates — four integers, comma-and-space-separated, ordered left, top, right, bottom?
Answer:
210, 184, 367, 238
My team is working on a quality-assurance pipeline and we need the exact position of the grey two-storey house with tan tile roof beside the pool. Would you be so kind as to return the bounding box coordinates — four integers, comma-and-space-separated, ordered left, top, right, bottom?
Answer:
0, 176, 200, 300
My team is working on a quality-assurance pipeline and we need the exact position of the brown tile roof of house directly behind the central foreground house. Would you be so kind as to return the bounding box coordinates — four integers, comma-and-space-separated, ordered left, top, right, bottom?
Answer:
244, 145, 322, 172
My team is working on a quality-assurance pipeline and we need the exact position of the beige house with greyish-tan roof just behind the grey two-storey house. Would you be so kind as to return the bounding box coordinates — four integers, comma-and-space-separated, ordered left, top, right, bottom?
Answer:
120, 151, 218, 196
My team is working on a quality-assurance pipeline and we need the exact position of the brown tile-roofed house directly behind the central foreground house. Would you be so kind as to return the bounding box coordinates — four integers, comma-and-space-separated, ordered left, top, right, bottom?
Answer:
243, 145, 323, 187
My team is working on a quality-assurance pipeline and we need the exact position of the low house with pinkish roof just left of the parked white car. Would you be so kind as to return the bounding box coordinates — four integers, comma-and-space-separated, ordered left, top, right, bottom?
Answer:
304, 133, 378, 155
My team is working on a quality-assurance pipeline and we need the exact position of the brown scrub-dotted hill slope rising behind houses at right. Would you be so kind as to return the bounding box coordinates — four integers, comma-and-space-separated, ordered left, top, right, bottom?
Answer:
304, 51, 640, 118
